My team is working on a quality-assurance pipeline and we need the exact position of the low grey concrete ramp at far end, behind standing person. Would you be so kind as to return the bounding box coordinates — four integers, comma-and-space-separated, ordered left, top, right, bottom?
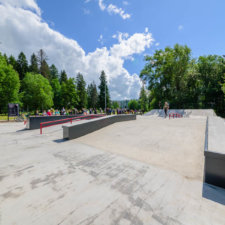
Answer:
144, 109, 216, 117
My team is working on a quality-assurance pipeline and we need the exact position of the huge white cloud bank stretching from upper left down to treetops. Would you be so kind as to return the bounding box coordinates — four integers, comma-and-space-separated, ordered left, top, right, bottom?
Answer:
0, 1, 153, 100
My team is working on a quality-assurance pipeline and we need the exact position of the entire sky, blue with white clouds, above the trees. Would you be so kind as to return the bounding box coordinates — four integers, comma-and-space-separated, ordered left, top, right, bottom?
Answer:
0, 0, 225, 100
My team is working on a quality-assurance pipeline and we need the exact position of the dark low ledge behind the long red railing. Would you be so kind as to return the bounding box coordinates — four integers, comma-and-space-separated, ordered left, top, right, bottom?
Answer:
26, 114, 97, 130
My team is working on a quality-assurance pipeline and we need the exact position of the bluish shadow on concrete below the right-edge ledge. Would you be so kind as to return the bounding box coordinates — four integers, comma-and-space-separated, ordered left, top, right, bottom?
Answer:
202, 183, 225, 205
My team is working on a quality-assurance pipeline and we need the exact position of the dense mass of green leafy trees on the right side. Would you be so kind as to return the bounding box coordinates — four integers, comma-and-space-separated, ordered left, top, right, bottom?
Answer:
140, 44, 225, 116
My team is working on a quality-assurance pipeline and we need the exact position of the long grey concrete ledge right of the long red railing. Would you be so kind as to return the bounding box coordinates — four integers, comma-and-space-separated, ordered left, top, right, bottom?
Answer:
63, 115, 136, 140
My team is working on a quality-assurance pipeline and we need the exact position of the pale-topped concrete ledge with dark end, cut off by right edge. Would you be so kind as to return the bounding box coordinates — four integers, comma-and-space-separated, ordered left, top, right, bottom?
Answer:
204, 117, 225, 188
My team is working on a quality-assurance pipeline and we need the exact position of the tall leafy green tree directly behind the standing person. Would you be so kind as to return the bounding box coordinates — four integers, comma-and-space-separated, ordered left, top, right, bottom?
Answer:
140, 44, 192, 108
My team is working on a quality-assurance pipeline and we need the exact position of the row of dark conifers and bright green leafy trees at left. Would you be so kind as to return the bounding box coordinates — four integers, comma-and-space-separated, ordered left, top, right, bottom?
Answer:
0, 49, 111, 113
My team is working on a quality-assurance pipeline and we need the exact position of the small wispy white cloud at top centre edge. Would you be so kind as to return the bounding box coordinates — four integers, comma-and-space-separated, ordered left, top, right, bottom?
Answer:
98, 0, 131, 20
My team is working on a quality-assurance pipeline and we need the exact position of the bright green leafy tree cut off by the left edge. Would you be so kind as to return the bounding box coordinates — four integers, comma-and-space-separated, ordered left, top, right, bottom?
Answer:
0, 53, 20, 112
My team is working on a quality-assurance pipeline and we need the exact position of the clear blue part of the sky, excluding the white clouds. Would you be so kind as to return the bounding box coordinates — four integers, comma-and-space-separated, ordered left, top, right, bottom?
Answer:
38, 0, 225, 73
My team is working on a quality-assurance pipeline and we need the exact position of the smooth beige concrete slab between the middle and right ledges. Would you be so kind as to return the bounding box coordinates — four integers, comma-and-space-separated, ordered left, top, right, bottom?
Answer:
77, 116, 206, 180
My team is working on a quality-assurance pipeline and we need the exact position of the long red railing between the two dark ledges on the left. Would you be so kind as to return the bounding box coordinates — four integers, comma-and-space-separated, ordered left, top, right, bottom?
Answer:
40, 114, 105, 134
